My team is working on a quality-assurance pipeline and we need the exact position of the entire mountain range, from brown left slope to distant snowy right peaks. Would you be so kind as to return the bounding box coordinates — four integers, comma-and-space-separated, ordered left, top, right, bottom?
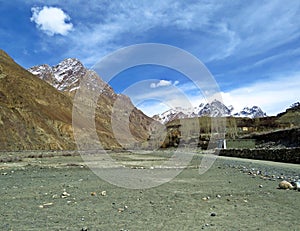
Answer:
0, 50, 299, 150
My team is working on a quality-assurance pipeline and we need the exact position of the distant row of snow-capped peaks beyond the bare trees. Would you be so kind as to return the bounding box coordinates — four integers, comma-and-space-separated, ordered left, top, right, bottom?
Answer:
152, 100, 267, 124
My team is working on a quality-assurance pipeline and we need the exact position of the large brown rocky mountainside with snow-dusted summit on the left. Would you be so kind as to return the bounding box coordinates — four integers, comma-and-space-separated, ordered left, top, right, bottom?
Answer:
0, 50, 153, 150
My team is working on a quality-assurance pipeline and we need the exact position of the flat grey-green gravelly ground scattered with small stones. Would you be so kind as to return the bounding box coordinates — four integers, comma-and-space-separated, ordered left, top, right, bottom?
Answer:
0, 152, 300, 231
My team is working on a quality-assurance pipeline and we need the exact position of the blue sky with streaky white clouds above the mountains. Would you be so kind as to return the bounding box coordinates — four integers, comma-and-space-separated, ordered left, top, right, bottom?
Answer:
0, 0, 300, 115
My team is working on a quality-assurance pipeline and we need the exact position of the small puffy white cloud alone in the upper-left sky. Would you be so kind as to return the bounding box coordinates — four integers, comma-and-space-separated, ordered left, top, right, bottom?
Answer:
30, 6, 73, 36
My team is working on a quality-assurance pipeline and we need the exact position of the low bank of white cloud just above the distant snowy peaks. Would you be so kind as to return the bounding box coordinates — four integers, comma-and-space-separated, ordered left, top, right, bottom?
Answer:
130, 72, 300, 116
